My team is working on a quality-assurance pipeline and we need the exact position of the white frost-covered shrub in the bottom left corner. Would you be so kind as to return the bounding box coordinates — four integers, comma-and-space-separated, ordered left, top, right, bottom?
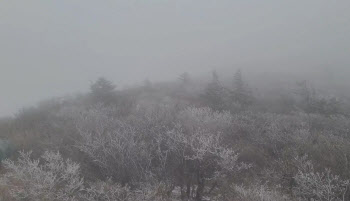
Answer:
1, 152, 83, 201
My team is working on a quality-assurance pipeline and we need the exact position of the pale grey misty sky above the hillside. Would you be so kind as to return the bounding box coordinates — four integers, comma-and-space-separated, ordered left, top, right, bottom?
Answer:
0, 0, 350, 116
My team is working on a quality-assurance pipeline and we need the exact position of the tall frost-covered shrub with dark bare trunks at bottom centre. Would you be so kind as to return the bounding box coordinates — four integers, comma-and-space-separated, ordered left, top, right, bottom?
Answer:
156, 108, 250, 200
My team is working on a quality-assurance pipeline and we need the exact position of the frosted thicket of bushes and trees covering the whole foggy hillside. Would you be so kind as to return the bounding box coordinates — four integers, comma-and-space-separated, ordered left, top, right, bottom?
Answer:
0, 71, 350, 201
